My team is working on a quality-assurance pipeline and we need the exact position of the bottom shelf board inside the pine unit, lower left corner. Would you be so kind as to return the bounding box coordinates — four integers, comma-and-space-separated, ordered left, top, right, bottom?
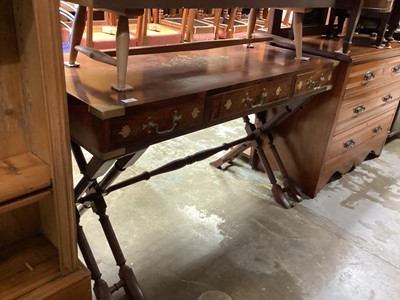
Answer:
0, 235, 60, 300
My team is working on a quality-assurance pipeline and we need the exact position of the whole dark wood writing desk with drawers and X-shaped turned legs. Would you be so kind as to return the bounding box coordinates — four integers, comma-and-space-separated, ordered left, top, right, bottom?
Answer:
65, 42, 336, 299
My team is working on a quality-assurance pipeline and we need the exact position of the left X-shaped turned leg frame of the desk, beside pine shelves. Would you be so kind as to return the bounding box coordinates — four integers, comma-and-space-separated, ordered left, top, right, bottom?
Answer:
72, 142, 145, 300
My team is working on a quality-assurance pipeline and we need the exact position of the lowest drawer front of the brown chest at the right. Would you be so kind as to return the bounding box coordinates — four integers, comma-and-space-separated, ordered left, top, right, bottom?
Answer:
326, 109, 394, 160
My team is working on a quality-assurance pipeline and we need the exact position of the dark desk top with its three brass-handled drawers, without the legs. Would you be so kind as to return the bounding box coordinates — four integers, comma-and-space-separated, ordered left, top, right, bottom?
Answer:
65, 42, 334, 158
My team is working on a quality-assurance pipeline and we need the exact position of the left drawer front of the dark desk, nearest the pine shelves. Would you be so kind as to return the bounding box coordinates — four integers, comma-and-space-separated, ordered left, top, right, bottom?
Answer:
110, 98, 205, 149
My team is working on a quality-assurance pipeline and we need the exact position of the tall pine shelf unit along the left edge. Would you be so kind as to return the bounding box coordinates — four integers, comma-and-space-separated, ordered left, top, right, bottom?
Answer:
0, 0, 91, 299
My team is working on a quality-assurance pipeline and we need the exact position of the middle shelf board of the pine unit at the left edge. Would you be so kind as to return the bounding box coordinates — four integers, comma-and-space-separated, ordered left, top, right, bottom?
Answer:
0, 153, 51, 203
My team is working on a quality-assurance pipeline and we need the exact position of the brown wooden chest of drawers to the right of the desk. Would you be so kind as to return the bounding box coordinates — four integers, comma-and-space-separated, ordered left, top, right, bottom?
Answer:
265, 39, 400, 197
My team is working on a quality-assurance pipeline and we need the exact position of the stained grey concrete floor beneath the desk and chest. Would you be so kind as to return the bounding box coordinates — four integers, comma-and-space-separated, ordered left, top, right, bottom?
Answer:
75, 120, 400, 300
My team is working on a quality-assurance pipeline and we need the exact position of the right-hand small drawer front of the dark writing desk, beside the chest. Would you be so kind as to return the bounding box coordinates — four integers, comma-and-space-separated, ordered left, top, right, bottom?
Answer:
293, 69, 333, 96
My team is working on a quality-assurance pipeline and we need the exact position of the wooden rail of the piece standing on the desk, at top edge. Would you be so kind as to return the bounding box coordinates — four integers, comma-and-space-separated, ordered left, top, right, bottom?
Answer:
70, 0, 338, 9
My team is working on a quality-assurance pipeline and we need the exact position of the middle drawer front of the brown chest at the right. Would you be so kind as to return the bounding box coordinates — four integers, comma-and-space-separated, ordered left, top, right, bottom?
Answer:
334, 83, 400, 135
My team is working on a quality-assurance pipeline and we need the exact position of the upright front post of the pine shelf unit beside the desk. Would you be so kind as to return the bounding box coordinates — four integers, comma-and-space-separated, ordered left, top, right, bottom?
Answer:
30, 0, 78, 274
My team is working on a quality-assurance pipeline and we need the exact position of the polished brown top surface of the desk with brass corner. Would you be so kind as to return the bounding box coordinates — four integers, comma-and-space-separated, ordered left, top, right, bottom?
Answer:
65, 43, 331, 118
